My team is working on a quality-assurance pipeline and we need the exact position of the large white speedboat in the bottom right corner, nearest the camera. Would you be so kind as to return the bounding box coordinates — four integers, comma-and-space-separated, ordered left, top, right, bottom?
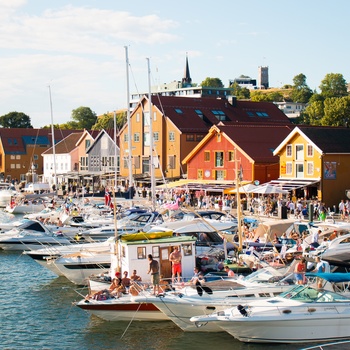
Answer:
191, 273, 350, 343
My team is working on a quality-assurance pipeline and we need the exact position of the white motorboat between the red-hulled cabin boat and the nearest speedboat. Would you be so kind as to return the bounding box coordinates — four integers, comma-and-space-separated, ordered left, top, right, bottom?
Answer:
134, 267, 294, 332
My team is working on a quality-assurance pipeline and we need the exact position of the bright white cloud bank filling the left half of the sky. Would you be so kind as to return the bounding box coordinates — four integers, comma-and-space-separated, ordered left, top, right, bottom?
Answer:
0, 0, 178, 126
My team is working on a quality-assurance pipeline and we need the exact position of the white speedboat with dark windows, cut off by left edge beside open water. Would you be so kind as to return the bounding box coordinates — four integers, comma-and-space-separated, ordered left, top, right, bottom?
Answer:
0, 220, 71, 251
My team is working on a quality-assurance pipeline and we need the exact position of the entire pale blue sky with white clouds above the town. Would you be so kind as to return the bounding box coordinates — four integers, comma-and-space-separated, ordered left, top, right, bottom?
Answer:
0, 0, 350, 127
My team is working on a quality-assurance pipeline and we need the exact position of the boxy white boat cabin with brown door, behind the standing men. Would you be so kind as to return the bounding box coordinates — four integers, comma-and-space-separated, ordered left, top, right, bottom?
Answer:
115, 236, 196, 282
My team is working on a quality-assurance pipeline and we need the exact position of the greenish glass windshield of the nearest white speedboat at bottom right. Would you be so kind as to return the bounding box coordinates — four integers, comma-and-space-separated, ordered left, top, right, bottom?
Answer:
280, 286, 350, 303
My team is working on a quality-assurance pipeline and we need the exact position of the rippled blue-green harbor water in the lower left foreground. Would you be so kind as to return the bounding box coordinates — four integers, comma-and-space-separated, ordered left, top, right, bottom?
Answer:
0, 212, 340, 350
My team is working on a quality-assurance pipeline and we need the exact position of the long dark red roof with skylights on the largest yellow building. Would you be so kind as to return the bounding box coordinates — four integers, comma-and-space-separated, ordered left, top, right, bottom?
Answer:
152, 95, 291, 133
